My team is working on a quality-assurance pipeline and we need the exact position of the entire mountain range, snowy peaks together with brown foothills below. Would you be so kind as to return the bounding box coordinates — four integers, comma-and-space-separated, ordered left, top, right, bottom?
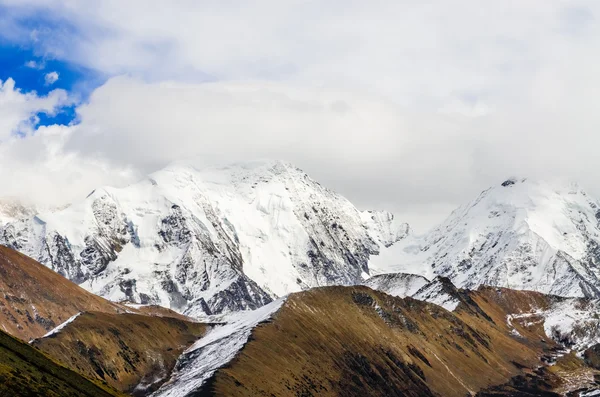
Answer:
0, 161, 600, 397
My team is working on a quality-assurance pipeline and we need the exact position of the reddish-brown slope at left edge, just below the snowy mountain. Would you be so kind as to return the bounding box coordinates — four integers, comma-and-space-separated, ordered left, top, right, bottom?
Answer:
0, 245, 126, 341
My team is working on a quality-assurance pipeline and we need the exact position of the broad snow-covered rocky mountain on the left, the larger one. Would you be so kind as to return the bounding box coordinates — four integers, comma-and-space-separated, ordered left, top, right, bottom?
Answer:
0, 161, 408, 316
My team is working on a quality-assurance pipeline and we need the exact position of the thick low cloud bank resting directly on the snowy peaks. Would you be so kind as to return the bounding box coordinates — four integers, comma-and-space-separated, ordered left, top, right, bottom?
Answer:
58, 71, 600, 230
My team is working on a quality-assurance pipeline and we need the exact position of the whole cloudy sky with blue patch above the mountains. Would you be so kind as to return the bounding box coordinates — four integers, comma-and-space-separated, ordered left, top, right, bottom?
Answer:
0, 0, 600, 231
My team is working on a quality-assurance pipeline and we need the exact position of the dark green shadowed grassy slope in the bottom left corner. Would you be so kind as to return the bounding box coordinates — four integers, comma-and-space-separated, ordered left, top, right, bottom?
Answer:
0, 324, 122, 397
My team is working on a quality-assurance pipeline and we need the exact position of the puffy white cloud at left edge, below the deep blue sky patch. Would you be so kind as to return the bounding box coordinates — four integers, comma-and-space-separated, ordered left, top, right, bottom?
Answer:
0, 79, 135, 205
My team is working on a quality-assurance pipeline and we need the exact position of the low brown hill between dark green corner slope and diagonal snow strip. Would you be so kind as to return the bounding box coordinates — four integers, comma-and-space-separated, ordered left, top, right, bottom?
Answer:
32, 312, 207, 395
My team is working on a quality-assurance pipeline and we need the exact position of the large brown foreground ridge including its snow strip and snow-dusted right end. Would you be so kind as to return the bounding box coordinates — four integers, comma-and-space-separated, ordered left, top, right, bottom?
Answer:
153, 279, 600, 397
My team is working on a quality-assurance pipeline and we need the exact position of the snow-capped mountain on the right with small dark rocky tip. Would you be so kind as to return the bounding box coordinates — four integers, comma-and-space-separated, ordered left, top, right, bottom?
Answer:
370, 179, 600, 297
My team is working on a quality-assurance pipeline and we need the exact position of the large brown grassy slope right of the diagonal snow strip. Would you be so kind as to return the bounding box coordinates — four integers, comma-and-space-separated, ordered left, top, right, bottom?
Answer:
202, 287, 553, 397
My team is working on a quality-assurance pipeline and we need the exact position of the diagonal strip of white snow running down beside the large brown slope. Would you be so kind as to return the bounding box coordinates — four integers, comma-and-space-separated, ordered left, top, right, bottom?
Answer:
152, 298, 285, 397
